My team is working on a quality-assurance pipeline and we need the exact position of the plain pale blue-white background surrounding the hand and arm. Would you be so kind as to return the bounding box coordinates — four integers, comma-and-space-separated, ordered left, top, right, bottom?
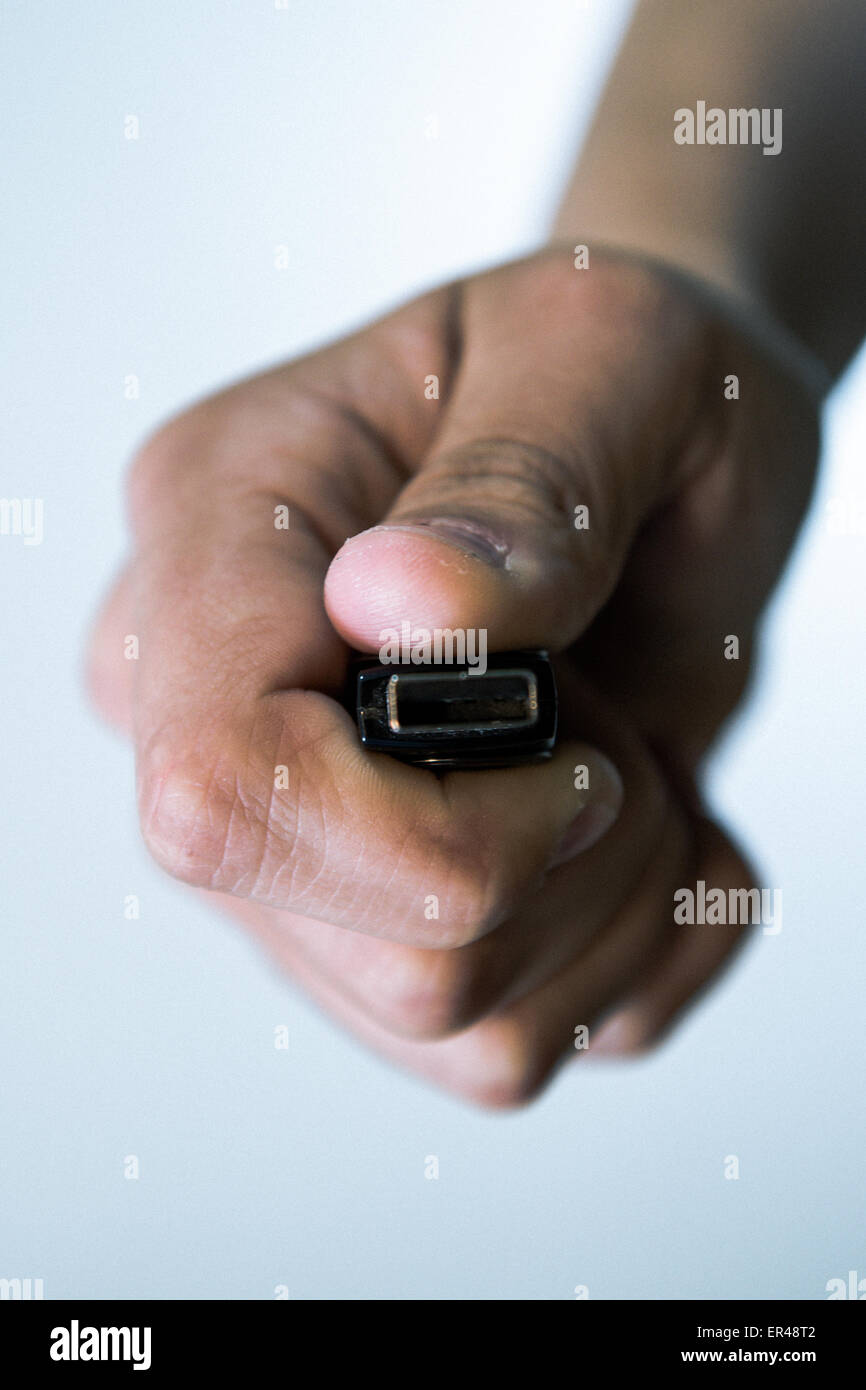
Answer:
0, 0, 866, 1300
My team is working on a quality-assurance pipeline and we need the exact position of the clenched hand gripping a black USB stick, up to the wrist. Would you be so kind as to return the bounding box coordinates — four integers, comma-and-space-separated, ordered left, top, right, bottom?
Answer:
90, 247, 817, 1105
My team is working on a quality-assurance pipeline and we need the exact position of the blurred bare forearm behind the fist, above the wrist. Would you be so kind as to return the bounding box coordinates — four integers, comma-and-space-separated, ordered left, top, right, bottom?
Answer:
555, 0, 866, 374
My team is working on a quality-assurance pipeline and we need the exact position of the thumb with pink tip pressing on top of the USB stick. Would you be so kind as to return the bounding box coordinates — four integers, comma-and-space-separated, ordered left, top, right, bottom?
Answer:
325, 252, 708, 651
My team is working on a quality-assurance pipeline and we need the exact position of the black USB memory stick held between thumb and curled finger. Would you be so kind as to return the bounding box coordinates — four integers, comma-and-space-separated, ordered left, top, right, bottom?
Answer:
352, 652, 556, 770
